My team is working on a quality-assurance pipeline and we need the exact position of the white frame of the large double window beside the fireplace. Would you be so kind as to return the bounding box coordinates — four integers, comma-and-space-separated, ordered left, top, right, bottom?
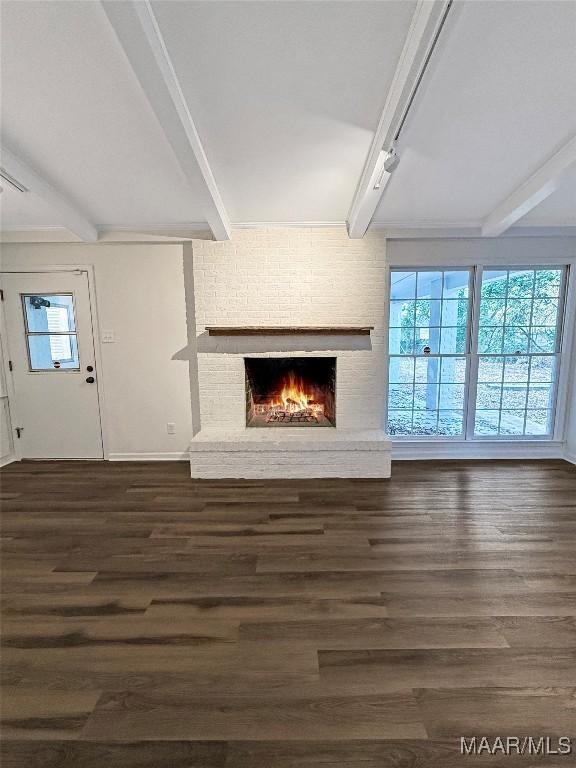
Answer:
384, 259, 576, 444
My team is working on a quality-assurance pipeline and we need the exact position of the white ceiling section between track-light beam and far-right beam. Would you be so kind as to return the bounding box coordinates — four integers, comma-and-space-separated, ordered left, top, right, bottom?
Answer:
375, 0, 576, 224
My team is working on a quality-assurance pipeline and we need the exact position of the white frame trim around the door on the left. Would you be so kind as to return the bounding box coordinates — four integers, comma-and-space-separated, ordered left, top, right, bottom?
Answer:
0, 264, 110, 461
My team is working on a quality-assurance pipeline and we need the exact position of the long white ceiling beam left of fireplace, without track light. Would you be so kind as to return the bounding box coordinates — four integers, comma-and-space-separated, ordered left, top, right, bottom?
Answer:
102, 0, 232, 240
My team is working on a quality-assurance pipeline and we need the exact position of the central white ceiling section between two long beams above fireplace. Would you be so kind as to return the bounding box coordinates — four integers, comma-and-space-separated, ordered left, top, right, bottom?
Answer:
154, 0, 416, 221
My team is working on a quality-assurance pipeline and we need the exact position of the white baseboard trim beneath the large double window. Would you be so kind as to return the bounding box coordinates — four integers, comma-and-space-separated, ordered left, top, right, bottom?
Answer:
392, 440, 566, 461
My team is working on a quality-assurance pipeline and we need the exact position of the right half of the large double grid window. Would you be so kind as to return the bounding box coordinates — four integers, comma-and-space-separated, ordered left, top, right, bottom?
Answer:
474, 269, 563, 437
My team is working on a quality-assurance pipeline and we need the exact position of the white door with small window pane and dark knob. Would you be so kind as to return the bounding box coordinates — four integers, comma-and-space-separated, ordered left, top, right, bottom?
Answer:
2, 270, 103, 459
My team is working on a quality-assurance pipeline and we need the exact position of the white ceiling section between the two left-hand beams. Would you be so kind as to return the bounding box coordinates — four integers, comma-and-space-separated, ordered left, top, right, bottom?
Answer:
0, 0, 204, 225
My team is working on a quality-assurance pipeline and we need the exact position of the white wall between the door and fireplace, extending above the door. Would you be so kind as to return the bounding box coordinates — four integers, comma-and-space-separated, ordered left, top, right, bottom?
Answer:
2, 243, 192, 459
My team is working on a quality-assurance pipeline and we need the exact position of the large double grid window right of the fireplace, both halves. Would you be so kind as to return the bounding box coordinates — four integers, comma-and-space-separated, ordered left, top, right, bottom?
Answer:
388, 267, 565, 439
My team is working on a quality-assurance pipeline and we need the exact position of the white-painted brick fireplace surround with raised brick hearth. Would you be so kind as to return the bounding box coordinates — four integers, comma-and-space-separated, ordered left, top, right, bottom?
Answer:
188, 227, 390, 478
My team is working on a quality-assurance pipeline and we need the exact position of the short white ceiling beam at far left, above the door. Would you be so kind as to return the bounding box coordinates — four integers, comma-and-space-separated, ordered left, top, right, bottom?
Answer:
1, 144, 98, 243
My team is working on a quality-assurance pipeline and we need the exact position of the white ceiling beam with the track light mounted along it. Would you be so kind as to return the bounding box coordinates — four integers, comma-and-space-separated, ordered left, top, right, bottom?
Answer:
347, 0, 451, 238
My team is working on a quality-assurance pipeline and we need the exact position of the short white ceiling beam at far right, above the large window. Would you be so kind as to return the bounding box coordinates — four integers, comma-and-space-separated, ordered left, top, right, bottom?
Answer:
482, 136, 576, 237
